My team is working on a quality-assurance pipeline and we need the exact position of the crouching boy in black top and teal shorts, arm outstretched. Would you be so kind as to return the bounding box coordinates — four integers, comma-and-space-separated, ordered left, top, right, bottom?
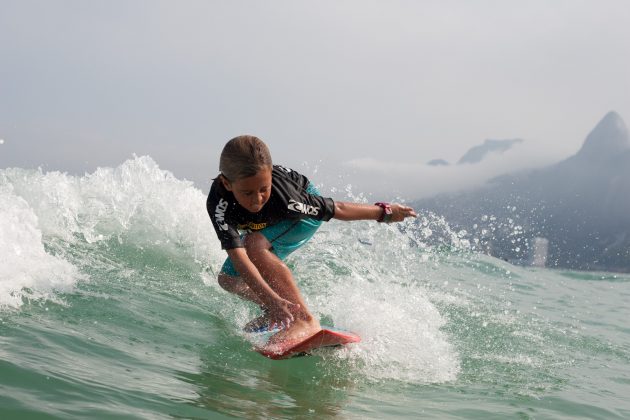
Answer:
206, 136, 416, 348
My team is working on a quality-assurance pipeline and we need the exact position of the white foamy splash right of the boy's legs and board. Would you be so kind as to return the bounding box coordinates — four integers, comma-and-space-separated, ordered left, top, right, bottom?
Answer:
295, 221, 460, 383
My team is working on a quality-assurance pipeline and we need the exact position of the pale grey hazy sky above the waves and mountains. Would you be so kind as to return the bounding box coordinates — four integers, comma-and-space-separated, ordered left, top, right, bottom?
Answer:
0, 0, 630, 199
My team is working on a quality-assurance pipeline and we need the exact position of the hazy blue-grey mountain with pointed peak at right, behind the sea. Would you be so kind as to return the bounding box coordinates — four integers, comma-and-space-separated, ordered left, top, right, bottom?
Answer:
416, 112, 630, 272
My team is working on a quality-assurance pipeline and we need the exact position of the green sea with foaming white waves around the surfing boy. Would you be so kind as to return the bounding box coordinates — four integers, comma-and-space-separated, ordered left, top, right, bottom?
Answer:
0, 157, 630, 419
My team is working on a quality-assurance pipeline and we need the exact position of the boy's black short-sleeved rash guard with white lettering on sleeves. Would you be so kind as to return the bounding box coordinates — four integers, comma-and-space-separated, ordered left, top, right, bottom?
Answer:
206, 165, 335, 249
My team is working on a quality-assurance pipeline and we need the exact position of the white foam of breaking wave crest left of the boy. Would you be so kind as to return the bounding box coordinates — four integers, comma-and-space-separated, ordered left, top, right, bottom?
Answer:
0, 157, 225, 306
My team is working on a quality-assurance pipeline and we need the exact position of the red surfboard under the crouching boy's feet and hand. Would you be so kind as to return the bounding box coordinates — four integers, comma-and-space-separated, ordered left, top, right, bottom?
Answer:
255, 327, 361, 360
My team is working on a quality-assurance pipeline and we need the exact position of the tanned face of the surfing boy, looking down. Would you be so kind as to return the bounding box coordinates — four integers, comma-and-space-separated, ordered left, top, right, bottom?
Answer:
221, 168, 271, 213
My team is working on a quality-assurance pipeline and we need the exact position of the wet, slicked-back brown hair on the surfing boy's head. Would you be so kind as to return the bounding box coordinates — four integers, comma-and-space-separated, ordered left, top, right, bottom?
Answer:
219, 135, 273, 181
